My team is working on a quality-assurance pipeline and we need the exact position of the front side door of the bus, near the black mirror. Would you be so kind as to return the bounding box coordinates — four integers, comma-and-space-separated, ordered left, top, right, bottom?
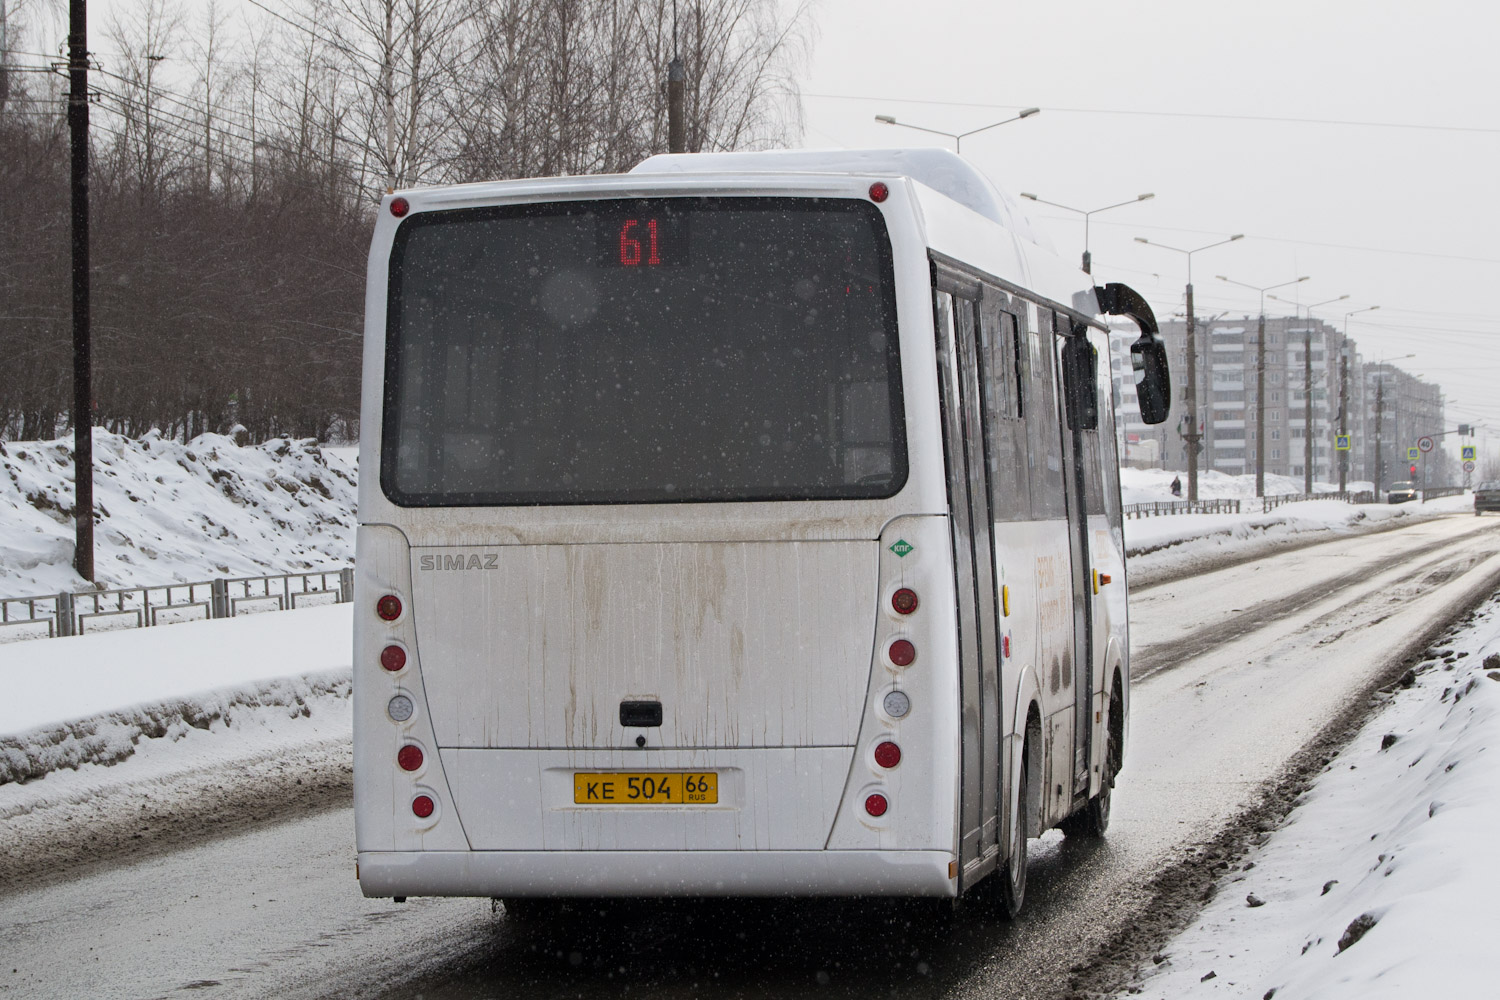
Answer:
1056, 315, 1104, 798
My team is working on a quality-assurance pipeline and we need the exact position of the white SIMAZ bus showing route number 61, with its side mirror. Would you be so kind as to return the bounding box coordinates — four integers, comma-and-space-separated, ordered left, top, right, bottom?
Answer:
354, 150, 1169, 913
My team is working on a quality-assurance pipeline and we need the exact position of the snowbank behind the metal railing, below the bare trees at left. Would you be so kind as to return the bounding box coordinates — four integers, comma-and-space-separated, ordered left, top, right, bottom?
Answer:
0, 429, 356, 597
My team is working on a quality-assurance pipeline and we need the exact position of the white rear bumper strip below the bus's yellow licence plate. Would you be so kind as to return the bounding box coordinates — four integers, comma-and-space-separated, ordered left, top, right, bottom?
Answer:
359, 850, 959, 898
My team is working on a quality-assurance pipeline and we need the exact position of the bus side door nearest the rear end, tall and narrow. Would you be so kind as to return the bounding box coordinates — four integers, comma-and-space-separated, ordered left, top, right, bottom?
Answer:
935, 273, 999, 889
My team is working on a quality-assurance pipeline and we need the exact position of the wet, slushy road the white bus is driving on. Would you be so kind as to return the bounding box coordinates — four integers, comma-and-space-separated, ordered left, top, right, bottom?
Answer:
0, 516, 1500, 1000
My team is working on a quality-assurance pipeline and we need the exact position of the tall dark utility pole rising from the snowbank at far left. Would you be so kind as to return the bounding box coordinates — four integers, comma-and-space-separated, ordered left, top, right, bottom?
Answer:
68, 0, 93, 583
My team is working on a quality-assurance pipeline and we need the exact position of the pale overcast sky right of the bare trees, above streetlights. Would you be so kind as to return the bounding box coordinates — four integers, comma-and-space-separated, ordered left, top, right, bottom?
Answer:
803, 0, 1500, 464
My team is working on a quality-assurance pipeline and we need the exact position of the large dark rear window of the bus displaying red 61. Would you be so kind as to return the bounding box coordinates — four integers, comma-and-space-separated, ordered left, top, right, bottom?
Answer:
381, 198, 906, 507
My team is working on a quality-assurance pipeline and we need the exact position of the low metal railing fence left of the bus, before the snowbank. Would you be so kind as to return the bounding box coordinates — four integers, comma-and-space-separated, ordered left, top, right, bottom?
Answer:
0, 567, 354, 642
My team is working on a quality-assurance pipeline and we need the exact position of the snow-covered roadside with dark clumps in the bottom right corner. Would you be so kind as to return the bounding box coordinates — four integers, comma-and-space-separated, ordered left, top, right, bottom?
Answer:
1131, 598, 1500, 1000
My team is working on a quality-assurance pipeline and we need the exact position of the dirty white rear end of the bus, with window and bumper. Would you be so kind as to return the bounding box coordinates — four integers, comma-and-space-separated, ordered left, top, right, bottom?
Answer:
354, 178, 959, 898
